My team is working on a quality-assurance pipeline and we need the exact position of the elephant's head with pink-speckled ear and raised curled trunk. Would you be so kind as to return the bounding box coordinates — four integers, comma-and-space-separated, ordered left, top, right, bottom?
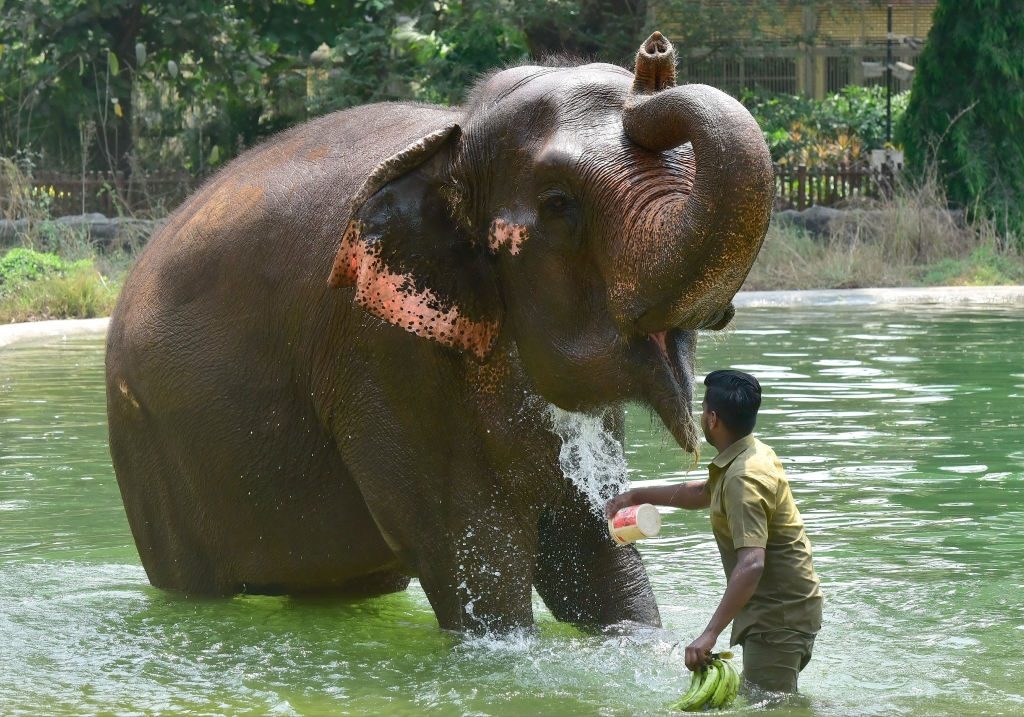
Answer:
331, 33, 773, 452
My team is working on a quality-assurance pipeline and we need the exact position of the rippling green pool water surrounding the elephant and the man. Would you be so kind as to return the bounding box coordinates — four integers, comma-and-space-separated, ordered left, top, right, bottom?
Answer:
0, 307, 1024, 717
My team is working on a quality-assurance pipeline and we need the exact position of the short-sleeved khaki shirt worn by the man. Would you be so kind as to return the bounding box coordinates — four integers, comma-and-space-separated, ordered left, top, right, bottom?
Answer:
705, 435, 821, 644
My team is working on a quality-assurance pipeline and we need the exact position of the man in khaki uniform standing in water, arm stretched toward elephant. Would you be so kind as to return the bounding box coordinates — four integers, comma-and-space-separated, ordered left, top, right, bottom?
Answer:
605, 371, 821, 692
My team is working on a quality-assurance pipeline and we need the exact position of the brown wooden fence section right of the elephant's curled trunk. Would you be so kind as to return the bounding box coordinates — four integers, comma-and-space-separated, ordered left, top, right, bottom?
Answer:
775, 165, 892, 209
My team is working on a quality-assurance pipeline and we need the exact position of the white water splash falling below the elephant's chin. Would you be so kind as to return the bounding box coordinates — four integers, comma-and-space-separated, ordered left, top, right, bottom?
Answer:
548, 406, 629, 518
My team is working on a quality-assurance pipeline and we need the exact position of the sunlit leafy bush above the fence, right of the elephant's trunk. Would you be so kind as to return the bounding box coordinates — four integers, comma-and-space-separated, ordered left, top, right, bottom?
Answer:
740, 86, 909, 167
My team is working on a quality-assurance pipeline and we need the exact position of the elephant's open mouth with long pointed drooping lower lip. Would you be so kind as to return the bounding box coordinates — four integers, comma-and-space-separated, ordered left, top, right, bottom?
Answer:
646, 329, 700, 455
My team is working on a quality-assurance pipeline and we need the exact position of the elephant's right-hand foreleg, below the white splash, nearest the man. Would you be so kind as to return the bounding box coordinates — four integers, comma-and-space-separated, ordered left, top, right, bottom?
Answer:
534, 498, 662, 628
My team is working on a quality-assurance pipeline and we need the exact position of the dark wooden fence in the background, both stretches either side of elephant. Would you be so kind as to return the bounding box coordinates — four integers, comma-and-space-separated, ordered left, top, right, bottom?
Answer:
18, 165, 891, 216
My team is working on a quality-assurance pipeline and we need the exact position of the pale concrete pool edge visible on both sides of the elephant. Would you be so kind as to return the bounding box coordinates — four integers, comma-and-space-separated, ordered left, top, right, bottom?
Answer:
0, 286, 1024, 348
